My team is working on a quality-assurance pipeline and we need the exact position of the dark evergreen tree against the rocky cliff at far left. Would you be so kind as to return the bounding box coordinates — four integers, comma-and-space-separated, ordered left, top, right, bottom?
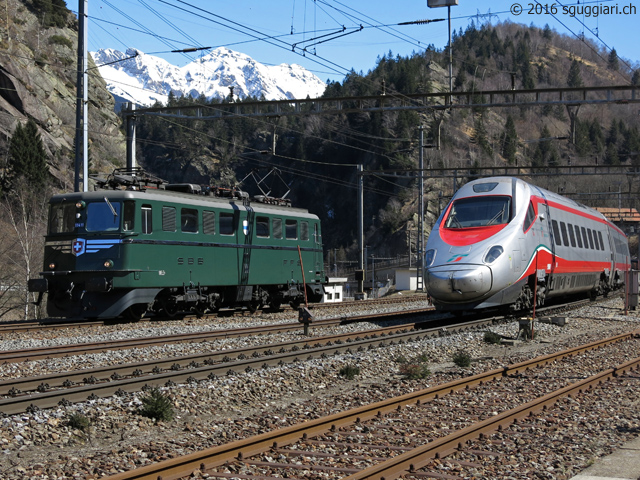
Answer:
9, 119, 49, 189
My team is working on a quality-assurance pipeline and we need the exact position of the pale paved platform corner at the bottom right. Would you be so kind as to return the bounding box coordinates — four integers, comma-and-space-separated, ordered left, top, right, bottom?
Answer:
570, 437, 640, 480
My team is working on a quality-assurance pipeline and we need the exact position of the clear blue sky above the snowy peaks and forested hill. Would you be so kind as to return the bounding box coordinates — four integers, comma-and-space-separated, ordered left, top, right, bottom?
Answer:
67, 0, 640, 81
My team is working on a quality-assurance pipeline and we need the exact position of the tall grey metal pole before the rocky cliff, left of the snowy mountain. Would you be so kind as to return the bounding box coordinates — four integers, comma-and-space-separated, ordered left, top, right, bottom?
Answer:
73, 0, 89, 192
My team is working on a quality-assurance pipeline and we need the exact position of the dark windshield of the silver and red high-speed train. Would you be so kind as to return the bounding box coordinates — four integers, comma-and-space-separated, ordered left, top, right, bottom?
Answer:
444, 195, 511, 228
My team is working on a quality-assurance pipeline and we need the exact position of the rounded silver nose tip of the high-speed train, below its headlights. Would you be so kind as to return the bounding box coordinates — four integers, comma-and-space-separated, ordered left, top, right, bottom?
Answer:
425, 265, 492, 303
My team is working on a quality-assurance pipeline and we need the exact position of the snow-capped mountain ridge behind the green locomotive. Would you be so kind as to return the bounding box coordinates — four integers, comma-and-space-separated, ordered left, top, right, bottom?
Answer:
91, 48, 326, 106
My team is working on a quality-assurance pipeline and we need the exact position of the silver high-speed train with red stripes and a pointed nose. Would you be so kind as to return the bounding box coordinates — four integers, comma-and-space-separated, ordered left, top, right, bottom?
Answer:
425, 177, 630, 311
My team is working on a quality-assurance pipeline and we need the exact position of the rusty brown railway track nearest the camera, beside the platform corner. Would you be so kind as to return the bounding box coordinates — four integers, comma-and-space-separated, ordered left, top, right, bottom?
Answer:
102, 331, 640, 480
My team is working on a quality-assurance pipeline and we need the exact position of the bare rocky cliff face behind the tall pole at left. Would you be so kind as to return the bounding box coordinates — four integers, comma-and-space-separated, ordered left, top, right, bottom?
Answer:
0, 0, 125, 190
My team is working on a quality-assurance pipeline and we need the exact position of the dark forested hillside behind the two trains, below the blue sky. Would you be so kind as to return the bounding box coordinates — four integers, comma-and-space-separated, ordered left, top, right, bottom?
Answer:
130, 23, 640, 259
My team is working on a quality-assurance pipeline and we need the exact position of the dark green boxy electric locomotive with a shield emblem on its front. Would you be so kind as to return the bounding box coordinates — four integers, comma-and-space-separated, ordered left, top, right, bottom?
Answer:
29, 171, 326, 318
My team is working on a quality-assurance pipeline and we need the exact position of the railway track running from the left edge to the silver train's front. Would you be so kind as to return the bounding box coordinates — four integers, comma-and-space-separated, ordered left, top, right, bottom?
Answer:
0, 319, 493, 414
